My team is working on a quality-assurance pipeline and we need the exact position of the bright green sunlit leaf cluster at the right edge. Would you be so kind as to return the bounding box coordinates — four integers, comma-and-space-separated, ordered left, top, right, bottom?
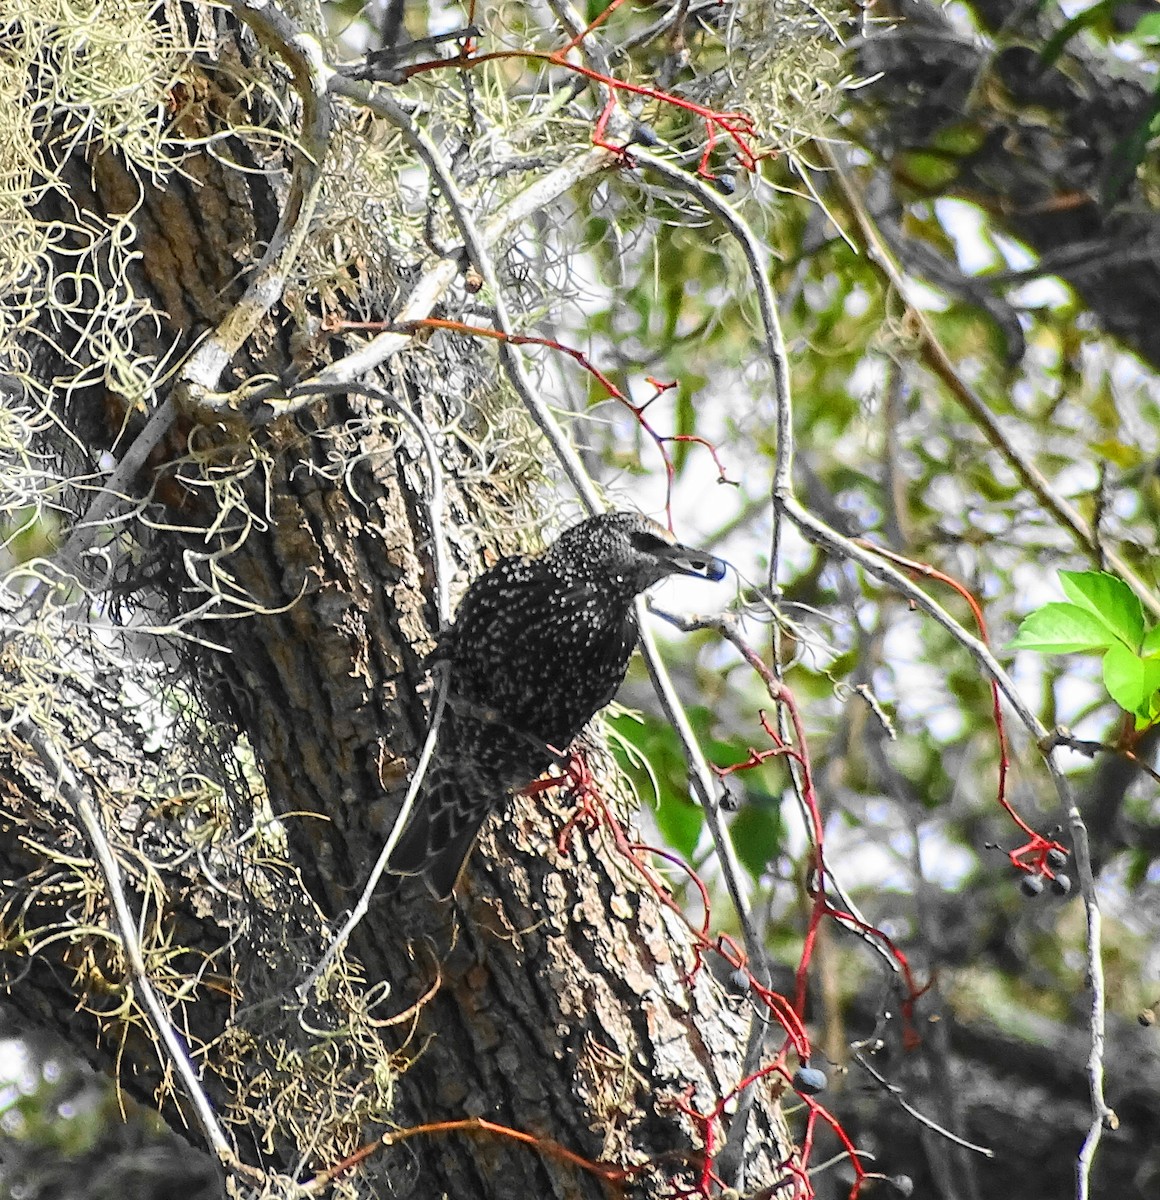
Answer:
1011, 571, 1160, 730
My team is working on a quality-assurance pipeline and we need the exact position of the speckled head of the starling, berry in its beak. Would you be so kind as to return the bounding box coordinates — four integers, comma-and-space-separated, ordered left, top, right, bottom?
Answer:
548, 512, 725, 594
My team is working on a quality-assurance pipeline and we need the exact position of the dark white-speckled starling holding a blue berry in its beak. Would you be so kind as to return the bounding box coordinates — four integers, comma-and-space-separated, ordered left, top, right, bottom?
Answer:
389, 512, 725, 900
